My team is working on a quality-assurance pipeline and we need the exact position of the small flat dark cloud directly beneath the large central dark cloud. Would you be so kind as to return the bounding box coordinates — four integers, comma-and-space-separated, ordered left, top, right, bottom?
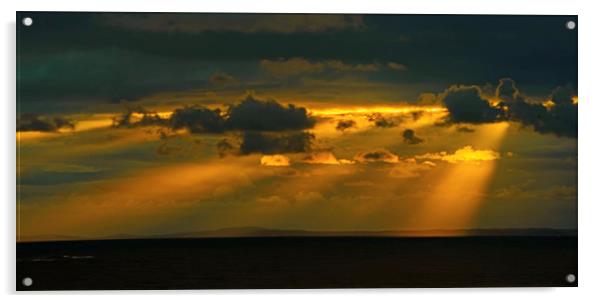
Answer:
240, 131, 314, 155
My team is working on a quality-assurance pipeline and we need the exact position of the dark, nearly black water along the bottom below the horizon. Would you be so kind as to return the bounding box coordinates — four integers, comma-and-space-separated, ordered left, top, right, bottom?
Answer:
16, 237, 578, 290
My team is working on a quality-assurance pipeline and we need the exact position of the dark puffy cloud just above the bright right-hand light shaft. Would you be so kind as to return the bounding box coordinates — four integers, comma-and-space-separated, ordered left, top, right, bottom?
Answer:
442, 85, 501, 123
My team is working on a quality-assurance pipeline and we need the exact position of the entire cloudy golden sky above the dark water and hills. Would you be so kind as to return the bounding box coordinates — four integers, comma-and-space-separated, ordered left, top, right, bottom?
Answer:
16, 13, 578, 240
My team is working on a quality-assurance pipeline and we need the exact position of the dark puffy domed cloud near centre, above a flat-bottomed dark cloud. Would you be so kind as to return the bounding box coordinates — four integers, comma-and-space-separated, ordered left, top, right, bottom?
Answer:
226, 95, 316, 131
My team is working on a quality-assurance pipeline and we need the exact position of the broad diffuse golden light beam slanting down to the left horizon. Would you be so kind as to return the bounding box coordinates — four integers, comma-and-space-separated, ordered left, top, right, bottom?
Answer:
17, 157, 272, 241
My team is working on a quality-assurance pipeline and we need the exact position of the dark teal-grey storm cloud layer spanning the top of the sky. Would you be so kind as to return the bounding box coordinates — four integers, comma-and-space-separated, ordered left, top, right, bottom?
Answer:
17, 12, 578, 112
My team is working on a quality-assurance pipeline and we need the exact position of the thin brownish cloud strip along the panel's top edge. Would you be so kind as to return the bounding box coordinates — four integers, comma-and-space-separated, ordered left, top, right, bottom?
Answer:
100, 13, 364, 34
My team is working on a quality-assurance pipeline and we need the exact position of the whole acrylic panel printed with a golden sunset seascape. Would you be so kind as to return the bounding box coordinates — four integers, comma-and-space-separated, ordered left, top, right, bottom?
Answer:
16, 12, 578, 290
